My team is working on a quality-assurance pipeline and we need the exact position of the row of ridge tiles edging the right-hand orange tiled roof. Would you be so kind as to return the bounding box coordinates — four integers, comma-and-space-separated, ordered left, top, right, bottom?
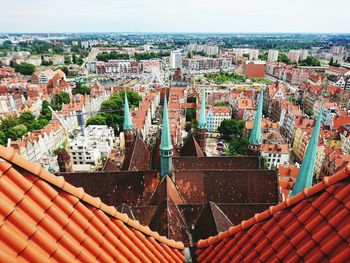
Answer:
196, 164, 350, 248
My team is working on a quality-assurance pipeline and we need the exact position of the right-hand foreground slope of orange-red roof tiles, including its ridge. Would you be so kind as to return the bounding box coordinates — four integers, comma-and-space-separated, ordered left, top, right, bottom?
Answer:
196, 166, 350, 262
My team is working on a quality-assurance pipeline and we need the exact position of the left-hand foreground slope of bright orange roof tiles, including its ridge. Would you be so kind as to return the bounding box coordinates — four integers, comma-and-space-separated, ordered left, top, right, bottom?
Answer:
0, 146, 184, 262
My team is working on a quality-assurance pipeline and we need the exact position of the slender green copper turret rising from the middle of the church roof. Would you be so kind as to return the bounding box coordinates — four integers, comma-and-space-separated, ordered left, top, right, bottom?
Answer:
159, 96, 173, 178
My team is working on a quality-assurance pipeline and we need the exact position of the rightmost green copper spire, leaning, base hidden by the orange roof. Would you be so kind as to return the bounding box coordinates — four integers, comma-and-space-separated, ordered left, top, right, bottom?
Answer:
289, 103, 323, 196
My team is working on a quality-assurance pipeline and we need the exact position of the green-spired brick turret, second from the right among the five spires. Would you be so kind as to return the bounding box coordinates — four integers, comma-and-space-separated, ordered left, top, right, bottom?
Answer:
248, 90, 264, 156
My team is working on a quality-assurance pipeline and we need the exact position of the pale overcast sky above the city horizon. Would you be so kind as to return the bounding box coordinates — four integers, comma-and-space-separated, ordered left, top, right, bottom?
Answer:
0, 0, 350, 33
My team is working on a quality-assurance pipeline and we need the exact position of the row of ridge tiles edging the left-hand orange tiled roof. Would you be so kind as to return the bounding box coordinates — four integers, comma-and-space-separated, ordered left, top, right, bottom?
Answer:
0, 145, 184, 249
